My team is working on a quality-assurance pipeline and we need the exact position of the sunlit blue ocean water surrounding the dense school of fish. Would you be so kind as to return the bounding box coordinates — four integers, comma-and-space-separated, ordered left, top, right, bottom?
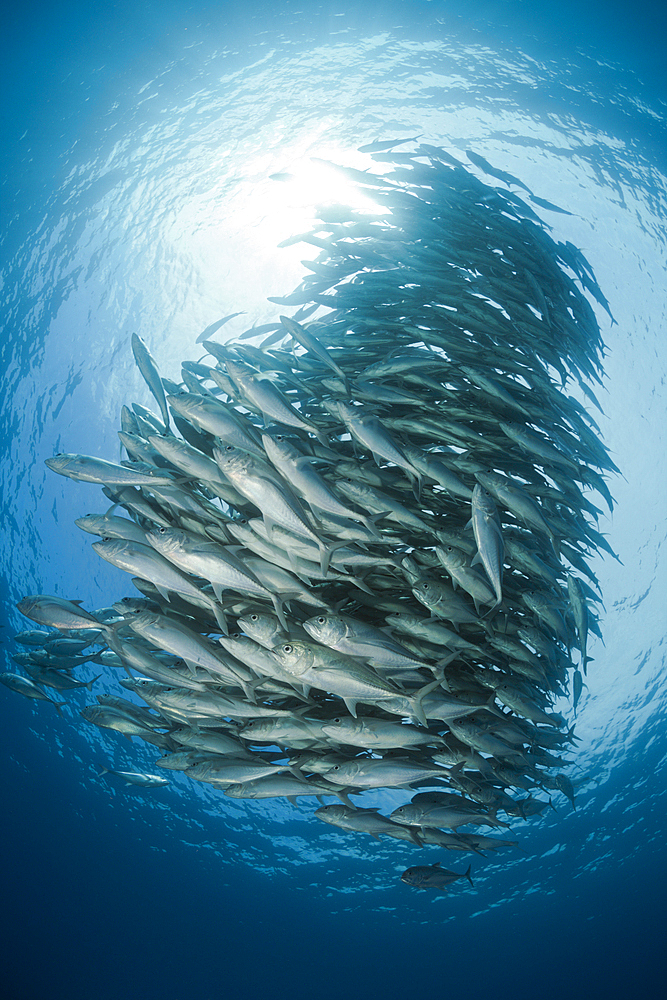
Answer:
0, 0, 667, 1000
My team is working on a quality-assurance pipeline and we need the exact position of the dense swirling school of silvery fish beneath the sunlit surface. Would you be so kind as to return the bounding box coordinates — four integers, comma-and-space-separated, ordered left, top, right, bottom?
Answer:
5, 141, 618, 889
